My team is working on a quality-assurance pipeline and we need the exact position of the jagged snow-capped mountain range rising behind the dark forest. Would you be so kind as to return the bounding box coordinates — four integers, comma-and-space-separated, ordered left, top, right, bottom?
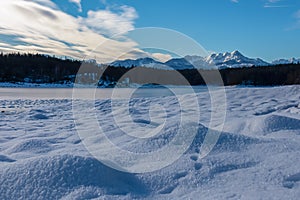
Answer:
109, 51, 300, 70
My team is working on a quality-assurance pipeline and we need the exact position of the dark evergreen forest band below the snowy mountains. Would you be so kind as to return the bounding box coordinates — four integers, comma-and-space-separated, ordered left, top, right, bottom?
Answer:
0, 53, 300, 87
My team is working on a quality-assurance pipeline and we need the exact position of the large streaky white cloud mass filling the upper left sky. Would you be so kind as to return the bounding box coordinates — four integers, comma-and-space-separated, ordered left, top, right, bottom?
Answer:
0, 0, 146, 62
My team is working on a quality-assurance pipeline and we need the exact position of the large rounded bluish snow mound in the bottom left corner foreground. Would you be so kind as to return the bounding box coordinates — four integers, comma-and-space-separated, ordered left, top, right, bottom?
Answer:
0, 155, 146, 199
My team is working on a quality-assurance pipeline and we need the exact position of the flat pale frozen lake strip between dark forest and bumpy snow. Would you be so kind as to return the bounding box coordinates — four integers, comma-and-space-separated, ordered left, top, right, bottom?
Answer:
0, 86, 207, 99
